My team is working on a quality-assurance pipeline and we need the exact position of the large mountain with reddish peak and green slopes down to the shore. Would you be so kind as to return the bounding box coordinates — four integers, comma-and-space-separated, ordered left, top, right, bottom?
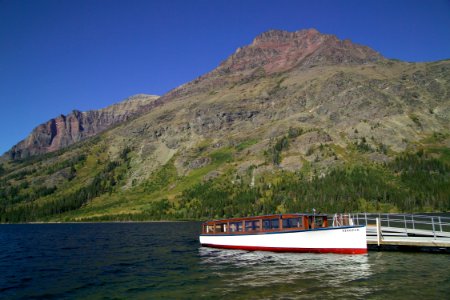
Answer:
0, 29, 450, 222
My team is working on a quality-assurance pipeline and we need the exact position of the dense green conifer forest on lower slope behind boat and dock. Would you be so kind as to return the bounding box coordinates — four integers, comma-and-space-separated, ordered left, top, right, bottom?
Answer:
171, 152, 450, 219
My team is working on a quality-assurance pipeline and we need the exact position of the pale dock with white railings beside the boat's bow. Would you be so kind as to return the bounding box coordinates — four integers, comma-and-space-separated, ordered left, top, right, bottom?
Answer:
333, 213, 450, 253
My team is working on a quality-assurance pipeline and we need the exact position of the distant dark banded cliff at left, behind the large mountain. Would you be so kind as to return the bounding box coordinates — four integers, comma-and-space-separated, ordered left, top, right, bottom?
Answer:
6, 94, 159, 159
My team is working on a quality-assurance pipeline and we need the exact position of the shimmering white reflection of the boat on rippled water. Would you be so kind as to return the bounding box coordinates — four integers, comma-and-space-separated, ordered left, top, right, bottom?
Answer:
199, 248, 371, 299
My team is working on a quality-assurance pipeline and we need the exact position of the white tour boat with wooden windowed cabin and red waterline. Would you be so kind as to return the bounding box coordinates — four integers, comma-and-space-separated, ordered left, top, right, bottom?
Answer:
199, 213, 367, 254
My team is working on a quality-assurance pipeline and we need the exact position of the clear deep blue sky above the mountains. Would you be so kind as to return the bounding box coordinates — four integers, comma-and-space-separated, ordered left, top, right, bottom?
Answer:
0, 0, 450, 153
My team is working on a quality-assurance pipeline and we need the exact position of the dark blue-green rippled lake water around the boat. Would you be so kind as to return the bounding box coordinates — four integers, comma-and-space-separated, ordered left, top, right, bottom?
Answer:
0, 222, 450, 299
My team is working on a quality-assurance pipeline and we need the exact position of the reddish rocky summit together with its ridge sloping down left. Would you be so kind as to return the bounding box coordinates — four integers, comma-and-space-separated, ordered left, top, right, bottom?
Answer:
161, 29, 384, 102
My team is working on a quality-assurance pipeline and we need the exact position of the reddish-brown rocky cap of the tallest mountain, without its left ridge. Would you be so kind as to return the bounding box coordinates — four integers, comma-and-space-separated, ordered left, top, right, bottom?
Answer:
218, 29, 382, 74
